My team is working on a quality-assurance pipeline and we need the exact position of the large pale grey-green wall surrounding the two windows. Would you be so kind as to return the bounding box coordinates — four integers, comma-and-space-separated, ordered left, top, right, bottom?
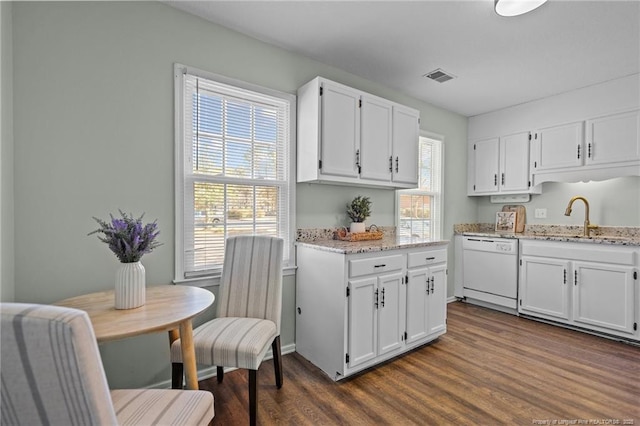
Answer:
7, 2, 470, 387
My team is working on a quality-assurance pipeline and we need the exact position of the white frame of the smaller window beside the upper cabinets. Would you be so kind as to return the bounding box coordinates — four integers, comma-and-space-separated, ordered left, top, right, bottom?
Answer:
395, 130, 444, 241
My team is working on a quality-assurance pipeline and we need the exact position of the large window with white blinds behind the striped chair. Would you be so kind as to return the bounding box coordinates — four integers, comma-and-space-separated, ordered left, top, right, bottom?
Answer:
176, 68, 293, 280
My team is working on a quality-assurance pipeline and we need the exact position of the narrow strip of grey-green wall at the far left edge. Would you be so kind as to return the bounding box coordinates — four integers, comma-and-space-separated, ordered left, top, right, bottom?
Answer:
0, 2, 15, 302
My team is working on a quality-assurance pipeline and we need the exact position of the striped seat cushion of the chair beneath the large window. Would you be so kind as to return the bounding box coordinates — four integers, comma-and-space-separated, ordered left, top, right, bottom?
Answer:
171, 317, 277, 370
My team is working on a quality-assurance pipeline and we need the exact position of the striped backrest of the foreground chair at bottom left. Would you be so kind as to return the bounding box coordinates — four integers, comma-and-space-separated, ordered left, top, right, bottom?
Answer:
0, 303, 116, 425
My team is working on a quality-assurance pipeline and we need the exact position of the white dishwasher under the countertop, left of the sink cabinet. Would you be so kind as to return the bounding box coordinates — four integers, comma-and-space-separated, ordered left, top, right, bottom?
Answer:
462, 236, 518, 313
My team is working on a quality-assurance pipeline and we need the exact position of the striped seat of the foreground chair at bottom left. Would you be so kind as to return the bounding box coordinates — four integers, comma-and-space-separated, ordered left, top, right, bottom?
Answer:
111, 389, 214, 426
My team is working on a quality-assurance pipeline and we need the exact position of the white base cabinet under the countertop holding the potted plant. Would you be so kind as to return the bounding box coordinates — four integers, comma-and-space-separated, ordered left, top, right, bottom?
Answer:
296, 243, 447, 380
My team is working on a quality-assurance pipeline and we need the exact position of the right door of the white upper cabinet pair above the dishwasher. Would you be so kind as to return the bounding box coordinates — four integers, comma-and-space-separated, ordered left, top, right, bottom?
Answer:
498, 132, 529, 191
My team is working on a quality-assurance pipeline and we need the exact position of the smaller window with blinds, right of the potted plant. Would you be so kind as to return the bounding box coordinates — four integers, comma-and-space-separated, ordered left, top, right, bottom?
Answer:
396, 136, 442, 240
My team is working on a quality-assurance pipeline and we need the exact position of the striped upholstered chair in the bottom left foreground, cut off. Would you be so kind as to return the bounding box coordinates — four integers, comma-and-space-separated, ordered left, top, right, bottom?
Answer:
0, 303, 214, 426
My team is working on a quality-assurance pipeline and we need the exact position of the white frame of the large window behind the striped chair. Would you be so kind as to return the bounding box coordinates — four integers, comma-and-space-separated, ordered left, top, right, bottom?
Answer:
173, 63, 297, 287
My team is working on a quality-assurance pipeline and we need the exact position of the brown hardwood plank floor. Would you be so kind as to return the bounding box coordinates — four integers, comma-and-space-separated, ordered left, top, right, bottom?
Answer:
200, 302, 640, 425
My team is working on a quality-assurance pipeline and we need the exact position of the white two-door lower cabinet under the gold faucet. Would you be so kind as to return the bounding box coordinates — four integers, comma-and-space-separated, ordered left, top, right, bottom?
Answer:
518, 240, 640, 340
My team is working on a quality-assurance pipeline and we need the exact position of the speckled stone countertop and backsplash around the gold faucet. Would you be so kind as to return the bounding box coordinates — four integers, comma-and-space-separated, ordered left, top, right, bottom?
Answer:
453, 223, 640, 246
